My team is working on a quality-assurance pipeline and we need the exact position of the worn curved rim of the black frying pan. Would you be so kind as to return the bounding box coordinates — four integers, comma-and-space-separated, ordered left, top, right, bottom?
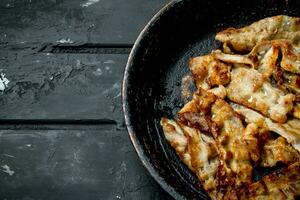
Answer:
122, 0, 185, 199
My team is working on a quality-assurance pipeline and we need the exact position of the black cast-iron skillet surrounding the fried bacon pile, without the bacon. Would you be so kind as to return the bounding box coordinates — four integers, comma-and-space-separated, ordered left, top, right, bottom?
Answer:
123, 0, 300, 199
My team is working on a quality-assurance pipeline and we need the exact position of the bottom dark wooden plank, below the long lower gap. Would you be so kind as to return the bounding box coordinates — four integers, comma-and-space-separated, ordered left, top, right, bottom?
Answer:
0, 128, 168, 200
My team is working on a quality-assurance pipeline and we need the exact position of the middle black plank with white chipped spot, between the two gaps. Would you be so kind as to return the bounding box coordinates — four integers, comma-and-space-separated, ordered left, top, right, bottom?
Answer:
0, 49, 128, 123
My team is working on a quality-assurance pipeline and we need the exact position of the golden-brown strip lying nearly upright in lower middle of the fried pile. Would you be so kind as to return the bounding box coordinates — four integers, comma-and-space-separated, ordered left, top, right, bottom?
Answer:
211, 99, 252, 187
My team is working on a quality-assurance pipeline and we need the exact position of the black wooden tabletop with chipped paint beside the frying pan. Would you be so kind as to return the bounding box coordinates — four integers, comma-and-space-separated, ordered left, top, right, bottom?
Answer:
0, 0, 170, 200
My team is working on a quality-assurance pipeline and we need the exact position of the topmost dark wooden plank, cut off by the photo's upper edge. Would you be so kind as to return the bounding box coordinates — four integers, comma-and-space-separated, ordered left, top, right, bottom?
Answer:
0, 0, 169, 44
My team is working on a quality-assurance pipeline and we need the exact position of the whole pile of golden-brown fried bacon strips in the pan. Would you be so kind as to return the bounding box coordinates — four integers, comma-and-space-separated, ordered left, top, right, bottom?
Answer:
161, 15, 300, 200
